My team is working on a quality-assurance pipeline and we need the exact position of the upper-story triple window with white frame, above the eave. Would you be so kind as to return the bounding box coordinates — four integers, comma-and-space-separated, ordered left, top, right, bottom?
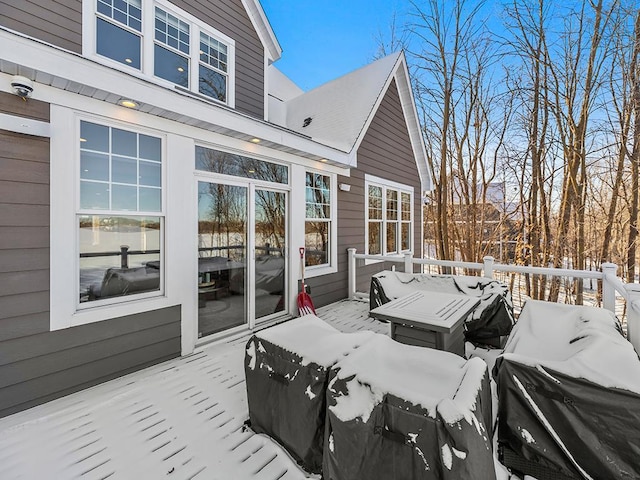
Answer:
83, 0, 235, 107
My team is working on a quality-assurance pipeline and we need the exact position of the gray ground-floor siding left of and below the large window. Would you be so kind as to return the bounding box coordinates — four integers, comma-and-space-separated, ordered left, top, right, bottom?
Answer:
0, 93, 181, 417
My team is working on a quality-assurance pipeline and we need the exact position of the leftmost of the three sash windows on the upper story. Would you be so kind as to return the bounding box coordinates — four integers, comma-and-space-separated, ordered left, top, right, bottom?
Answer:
96, 0, 142, 70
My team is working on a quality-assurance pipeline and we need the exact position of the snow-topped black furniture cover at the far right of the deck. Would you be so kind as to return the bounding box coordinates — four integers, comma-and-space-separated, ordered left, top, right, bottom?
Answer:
494, 300, 640, 480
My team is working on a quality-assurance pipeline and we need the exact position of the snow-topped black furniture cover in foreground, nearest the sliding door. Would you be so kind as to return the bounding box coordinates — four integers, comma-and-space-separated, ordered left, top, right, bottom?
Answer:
245, 315, 374, 473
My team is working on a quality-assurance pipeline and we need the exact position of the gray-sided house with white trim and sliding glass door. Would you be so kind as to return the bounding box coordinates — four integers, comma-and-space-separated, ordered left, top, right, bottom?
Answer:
0, 0, 430, 416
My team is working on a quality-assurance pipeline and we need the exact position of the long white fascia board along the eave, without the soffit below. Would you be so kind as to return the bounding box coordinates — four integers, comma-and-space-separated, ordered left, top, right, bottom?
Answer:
0, 29, 350, 167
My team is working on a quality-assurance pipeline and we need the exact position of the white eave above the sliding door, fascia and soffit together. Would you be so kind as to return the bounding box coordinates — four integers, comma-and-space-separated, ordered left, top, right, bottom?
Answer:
0, 27, 351, 167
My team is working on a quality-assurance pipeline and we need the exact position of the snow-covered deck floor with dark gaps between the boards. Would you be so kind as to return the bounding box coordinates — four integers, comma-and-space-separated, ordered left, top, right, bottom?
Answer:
0, 301, 388, 480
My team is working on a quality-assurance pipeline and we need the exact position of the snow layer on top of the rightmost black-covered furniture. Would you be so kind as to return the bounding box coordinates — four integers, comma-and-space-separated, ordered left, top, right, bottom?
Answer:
503, 300, 640, 393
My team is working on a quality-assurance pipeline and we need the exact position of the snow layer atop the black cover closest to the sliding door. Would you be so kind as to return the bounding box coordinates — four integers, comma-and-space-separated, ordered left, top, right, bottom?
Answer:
254, 315, 375, 368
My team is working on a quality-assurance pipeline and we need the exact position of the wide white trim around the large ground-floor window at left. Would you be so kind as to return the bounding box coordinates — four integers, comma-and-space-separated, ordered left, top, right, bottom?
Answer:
50, 105, 175, 330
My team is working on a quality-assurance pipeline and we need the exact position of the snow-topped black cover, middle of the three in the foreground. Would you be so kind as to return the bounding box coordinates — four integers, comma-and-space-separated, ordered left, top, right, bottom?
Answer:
323, 334, 495, 480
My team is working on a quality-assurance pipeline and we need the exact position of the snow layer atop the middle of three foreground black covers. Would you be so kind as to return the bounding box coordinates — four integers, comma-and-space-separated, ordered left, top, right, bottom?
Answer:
329, 335, 487, 424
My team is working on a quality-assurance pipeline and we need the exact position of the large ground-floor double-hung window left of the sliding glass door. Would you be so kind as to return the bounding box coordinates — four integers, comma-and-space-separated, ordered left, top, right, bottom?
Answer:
76, 120, 164, 305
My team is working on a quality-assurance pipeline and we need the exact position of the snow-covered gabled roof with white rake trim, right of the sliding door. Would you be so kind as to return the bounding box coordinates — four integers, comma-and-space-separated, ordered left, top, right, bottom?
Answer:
284, 52, 431, 190
